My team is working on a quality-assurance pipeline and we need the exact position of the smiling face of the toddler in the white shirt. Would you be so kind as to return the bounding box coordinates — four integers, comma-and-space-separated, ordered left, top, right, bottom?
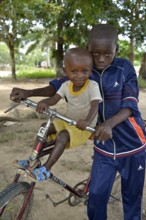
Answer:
64, 56, 92, 87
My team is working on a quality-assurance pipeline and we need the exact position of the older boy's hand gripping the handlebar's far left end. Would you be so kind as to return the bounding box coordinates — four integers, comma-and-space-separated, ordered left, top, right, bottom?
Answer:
10, 88, 28, 102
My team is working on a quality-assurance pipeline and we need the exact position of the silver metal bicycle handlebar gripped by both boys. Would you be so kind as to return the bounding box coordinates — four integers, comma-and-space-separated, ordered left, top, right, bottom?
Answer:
5, 99, 95, 132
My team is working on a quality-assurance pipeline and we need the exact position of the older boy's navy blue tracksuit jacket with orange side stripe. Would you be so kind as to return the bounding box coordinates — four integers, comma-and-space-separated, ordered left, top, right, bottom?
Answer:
50, 58, 146, 158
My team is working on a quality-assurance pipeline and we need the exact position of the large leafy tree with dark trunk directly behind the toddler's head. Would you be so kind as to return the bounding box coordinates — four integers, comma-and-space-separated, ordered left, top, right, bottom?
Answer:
24, 0, 102, 76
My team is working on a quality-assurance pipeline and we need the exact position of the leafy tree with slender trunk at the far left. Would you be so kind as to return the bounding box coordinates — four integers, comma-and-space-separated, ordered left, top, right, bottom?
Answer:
0, 0, 59, 79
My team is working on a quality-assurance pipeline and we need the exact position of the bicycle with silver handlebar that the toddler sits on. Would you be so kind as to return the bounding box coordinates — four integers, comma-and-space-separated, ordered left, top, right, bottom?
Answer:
0, 99, 124, 220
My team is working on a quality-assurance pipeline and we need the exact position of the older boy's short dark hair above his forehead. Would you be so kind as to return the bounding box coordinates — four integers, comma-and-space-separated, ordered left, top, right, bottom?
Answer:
88, 24, 118, 44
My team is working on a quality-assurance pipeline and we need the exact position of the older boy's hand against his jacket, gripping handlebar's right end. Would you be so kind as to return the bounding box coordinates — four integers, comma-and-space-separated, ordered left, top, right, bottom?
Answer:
94, 122, 112, 141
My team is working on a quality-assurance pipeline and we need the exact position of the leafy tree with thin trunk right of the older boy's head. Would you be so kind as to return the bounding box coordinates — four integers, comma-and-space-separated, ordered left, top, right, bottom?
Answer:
113, 0, 146, 63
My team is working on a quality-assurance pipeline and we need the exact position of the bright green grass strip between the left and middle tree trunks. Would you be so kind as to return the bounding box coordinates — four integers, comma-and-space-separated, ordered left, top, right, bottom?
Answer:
17, 68, 56, 79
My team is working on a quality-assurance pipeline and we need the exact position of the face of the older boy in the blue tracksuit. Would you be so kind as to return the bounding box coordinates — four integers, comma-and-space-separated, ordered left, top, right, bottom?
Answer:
88, 36, 116, 72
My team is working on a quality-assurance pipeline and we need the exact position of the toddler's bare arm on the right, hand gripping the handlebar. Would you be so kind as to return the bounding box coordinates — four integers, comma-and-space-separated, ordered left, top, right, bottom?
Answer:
76, 100, 99, 130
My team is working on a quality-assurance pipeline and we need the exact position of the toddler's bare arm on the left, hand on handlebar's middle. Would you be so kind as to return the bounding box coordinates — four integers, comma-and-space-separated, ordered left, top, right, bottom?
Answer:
36, 94, 62, 113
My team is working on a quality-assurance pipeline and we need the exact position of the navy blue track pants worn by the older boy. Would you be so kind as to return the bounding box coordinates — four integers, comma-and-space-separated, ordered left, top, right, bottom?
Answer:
87, 151, 145, 220
